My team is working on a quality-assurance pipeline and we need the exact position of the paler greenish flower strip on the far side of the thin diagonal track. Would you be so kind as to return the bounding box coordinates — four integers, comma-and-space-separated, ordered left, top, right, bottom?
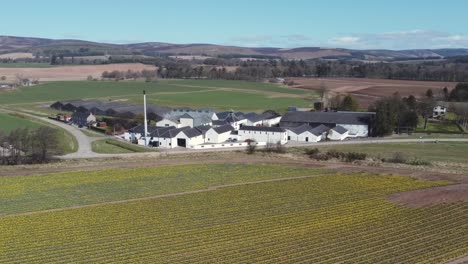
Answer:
0, 164, 329, 215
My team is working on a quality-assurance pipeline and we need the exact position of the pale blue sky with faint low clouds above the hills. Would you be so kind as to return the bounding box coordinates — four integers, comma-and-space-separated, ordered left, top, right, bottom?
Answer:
0, 0, 468, 49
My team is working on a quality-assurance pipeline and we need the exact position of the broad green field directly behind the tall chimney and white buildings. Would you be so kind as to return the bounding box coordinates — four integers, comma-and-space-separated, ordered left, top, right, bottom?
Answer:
0, 80, 317, 113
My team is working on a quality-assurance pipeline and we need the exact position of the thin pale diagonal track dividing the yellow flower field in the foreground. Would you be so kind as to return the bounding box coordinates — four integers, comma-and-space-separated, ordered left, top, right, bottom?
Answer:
0, 172, 330, 219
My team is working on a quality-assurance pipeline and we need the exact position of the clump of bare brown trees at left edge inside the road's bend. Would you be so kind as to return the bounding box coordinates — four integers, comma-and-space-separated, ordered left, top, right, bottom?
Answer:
0, 126, 62, 165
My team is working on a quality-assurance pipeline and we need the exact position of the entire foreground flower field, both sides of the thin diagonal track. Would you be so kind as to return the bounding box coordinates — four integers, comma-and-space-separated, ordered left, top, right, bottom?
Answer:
0, 164, 468, 263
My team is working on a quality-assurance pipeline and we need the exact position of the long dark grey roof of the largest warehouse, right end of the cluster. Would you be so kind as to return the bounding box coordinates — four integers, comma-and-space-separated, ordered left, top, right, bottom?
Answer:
281, 112, 375, 125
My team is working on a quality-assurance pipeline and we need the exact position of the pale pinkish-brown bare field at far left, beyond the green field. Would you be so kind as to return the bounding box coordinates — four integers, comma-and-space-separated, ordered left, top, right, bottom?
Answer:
0, 63, 156, 81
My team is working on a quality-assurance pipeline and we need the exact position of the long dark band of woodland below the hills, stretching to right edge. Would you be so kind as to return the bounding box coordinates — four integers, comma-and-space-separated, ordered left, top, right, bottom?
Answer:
137, 58, 468, 82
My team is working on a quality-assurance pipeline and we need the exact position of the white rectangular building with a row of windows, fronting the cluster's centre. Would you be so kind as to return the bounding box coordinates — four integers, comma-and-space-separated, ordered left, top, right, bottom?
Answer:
239, 126, 288, 144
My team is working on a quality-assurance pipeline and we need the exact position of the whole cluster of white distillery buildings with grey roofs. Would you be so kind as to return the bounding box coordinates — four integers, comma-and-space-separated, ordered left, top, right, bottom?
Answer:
123, 108, 375, 149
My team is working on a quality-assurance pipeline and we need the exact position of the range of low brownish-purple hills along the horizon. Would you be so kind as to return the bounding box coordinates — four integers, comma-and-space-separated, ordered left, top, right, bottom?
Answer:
0, 36, 468, 61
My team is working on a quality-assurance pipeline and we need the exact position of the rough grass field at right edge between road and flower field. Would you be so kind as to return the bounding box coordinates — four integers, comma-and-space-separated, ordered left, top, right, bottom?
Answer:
312, 142, 468, 163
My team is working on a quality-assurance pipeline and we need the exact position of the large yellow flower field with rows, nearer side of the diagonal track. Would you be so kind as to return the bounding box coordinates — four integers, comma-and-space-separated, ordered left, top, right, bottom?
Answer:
0, 174, 468, 263
